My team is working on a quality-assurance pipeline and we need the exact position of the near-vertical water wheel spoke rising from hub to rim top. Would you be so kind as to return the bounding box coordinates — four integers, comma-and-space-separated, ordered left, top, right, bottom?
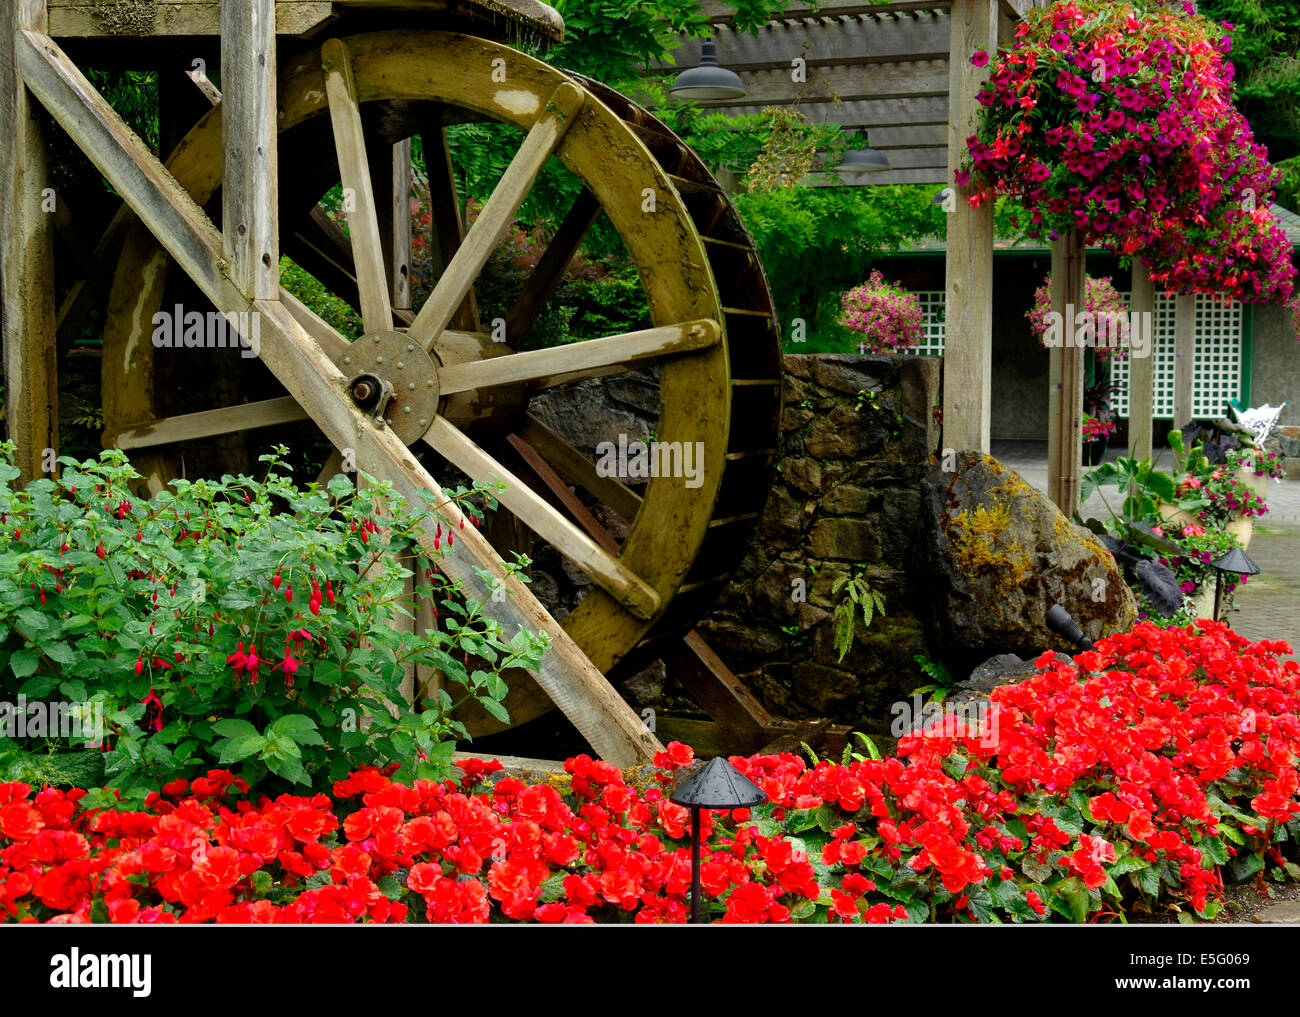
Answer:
321, 39, 393, 332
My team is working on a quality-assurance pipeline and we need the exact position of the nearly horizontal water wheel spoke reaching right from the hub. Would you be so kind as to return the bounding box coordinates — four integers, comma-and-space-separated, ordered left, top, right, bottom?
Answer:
438, 319, 722, 394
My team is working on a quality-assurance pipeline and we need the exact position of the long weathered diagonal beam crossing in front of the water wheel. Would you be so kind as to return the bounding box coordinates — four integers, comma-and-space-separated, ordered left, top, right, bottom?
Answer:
17, 31, 663, 766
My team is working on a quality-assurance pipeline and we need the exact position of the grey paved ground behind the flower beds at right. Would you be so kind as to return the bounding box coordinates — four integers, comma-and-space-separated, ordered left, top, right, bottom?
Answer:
992, 441, 1300, 650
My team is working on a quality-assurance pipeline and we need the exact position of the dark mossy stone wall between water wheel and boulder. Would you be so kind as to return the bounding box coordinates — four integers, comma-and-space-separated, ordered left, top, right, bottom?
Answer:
696, 355, 943, 735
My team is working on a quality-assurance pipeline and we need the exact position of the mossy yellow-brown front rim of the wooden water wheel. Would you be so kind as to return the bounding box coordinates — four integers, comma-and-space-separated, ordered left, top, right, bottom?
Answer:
103, 31, 757, 732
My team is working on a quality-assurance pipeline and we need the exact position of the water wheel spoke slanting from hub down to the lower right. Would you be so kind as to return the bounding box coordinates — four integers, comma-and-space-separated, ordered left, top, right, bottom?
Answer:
424, 417, 659, 619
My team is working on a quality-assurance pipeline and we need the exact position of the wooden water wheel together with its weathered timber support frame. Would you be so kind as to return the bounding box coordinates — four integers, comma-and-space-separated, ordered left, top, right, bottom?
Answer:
0, 0, 828, 766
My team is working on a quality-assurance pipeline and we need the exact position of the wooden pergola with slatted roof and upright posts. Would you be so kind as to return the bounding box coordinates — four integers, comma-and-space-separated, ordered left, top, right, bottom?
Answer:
654, 0, 1195, 514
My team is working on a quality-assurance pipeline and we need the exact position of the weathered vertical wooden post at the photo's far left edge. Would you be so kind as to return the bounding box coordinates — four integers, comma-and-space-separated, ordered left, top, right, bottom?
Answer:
0, 0, 59, 484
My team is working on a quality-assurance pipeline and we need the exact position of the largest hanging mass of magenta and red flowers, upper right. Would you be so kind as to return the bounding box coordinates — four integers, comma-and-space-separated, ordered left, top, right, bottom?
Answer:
957, 0, 1295, 302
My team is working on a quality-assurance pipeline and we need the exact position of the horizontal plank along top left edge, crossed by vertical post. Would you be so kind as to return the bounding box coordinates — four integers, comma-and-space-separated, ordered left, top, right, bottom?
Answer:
49, 0, 334, 39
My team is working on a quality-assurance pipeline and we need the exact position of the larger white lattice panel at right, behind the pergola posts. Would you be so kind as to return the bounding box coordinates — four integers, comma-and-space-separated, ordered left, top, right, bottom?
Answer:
1110, 293, 1243, 420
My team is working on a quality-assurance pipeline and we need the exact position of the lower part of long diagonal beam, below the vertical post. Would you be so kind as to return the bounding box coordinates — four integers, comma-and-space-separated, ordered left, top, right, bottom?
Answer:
256, 302, 663, 766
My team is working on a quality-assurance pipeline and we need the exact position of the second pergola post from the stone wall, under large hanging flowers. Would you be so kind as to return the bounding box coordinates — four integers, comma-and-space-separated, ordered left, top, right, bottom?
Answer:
1048, 230, 1087, 515
